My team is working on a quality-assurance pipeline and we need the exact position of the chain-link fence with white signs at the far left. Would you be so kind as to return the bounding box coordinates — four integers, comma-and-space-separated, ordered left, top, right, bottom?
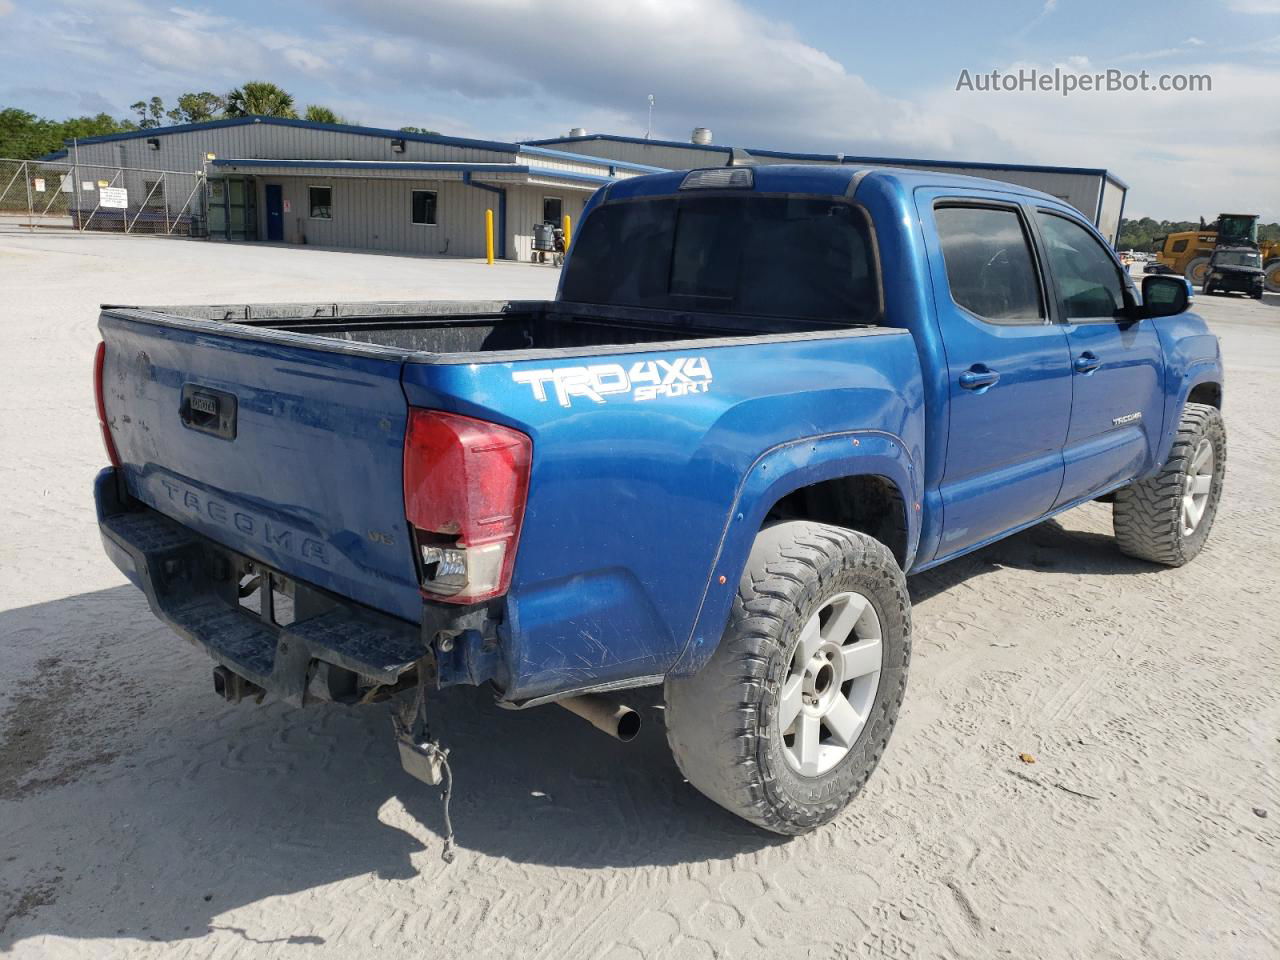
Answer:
0, 159, 209, 237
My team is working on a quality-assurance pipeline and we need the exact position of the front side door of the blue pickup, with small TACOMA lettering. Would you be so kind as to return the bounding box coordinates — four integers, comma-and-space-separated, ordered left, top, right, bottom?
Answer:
1036, 209, 1165, 504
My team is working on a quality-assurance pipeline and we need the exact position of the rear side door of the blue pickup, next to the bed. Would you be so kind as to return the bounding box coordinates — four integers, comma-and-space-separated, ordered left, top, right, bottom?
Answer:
916, 191, 1071, 559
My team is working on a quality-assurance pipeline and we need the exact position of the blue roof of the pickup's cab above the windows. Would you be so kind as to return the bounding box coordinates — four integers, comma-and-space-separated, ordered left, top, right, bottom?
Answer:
607, 164, 1061, 204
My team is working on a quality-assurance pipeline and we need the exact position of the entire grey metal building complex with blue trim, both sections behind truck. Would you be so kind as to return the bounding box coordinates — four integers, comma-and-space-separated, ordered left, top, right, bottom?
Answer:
45, 116, 1128, 260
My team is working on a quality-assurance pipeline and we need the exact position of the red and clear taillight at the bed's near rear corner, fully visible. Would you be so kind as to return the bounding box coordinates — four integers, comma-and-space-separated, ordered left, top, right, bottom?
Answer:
404, 408, 534, 603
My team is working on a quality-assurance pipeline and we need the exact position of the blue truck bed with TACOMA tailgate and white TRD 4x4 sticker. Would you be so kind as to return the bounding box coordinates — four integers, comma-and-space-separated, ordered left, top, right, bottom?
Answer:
99, 293, 920, 700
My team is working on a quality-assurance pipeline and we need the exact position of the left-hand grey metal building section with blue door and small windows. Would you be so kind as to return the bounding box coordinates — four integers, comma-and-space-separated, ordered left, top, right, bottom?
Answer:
49, 116, 655, 260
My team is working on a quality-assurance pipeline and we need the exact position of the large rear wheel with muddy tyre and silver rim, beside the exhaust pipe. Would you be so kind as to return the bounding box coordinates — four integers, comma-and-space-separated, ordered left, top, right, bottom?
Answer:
666, 521, 911, 835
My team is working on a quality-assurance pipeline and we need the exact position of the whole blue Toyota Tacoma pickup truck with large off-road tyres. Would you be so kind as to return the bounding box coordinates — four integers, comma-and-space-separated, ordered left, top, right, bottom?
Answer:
96, 165, 1226, 833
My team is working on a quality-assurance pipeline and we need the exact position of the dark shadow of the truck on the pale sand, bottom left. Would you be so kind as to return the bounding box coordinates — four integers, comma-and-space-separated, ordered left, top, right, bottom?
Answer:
0, 586, 785, 951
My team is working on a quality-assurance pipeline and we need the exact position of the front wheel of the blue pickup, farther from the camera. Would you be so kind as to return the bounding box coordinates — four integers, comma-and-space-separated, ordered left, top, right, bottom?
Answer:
1111, 403, 1226, 567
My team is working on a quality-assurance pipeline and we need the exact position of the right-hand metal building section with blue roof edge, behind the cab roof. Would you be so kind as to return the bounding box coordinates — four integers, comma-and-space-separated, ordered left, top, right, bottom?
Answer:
525, 128, 1129, 244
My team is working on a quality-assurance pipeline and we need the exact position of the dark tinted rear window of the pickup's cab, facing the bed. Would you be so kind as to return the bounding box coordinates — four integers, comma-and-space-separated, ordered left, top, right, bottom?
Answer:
562, 193, 881, 325
